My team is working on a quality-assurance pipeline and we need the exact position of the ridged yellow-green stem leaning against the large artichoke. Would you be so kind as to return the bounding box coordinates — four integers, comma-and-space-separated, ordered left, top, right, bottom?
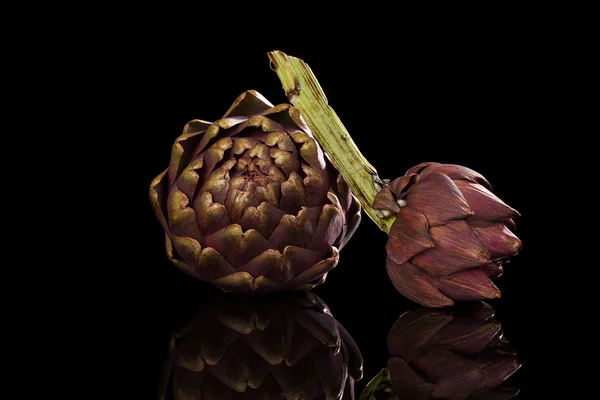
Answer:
269, 51, 396, 233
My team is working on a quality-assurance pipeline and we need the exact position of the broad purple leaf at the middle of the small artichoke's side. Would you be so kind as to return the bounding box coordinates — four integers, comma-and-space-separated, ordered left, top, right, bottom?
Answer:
411, 221, 491, 277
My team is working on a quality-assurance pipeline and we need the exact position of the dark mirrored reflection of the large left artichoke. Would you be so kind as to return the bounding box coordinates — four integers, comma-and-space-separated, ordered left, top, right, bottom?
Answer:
160, 292, 362, 400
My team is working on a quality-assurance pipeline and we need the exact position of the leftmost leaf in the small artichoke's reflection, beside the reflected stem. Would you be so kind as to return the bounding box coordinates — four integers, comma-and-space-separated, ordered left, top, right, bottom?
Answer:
388, 357, 433, 400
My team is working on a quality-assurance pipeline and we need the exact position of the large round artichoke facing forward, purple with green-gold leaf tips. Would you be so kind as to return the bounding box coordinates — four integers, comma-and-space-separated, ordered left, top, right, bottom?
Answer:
150, 90, 361, 293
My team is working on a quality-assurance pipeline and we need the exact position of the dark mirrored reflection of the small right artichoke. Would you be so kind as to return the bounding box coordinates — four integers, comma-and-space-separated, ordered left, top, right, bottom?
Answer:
361, 302, 521, 400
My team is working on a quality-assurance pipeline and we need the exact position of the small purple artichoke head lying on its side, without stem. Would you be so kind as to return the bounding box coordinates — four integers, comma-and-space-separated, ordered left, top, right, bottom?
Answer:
373, 163, 521, 307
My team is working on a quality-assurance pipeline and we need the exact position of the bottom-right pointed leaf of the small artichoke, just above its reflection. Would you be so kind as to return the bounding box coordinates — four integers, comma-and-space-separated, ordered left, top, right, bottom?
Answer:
438, 268, 500, 301
